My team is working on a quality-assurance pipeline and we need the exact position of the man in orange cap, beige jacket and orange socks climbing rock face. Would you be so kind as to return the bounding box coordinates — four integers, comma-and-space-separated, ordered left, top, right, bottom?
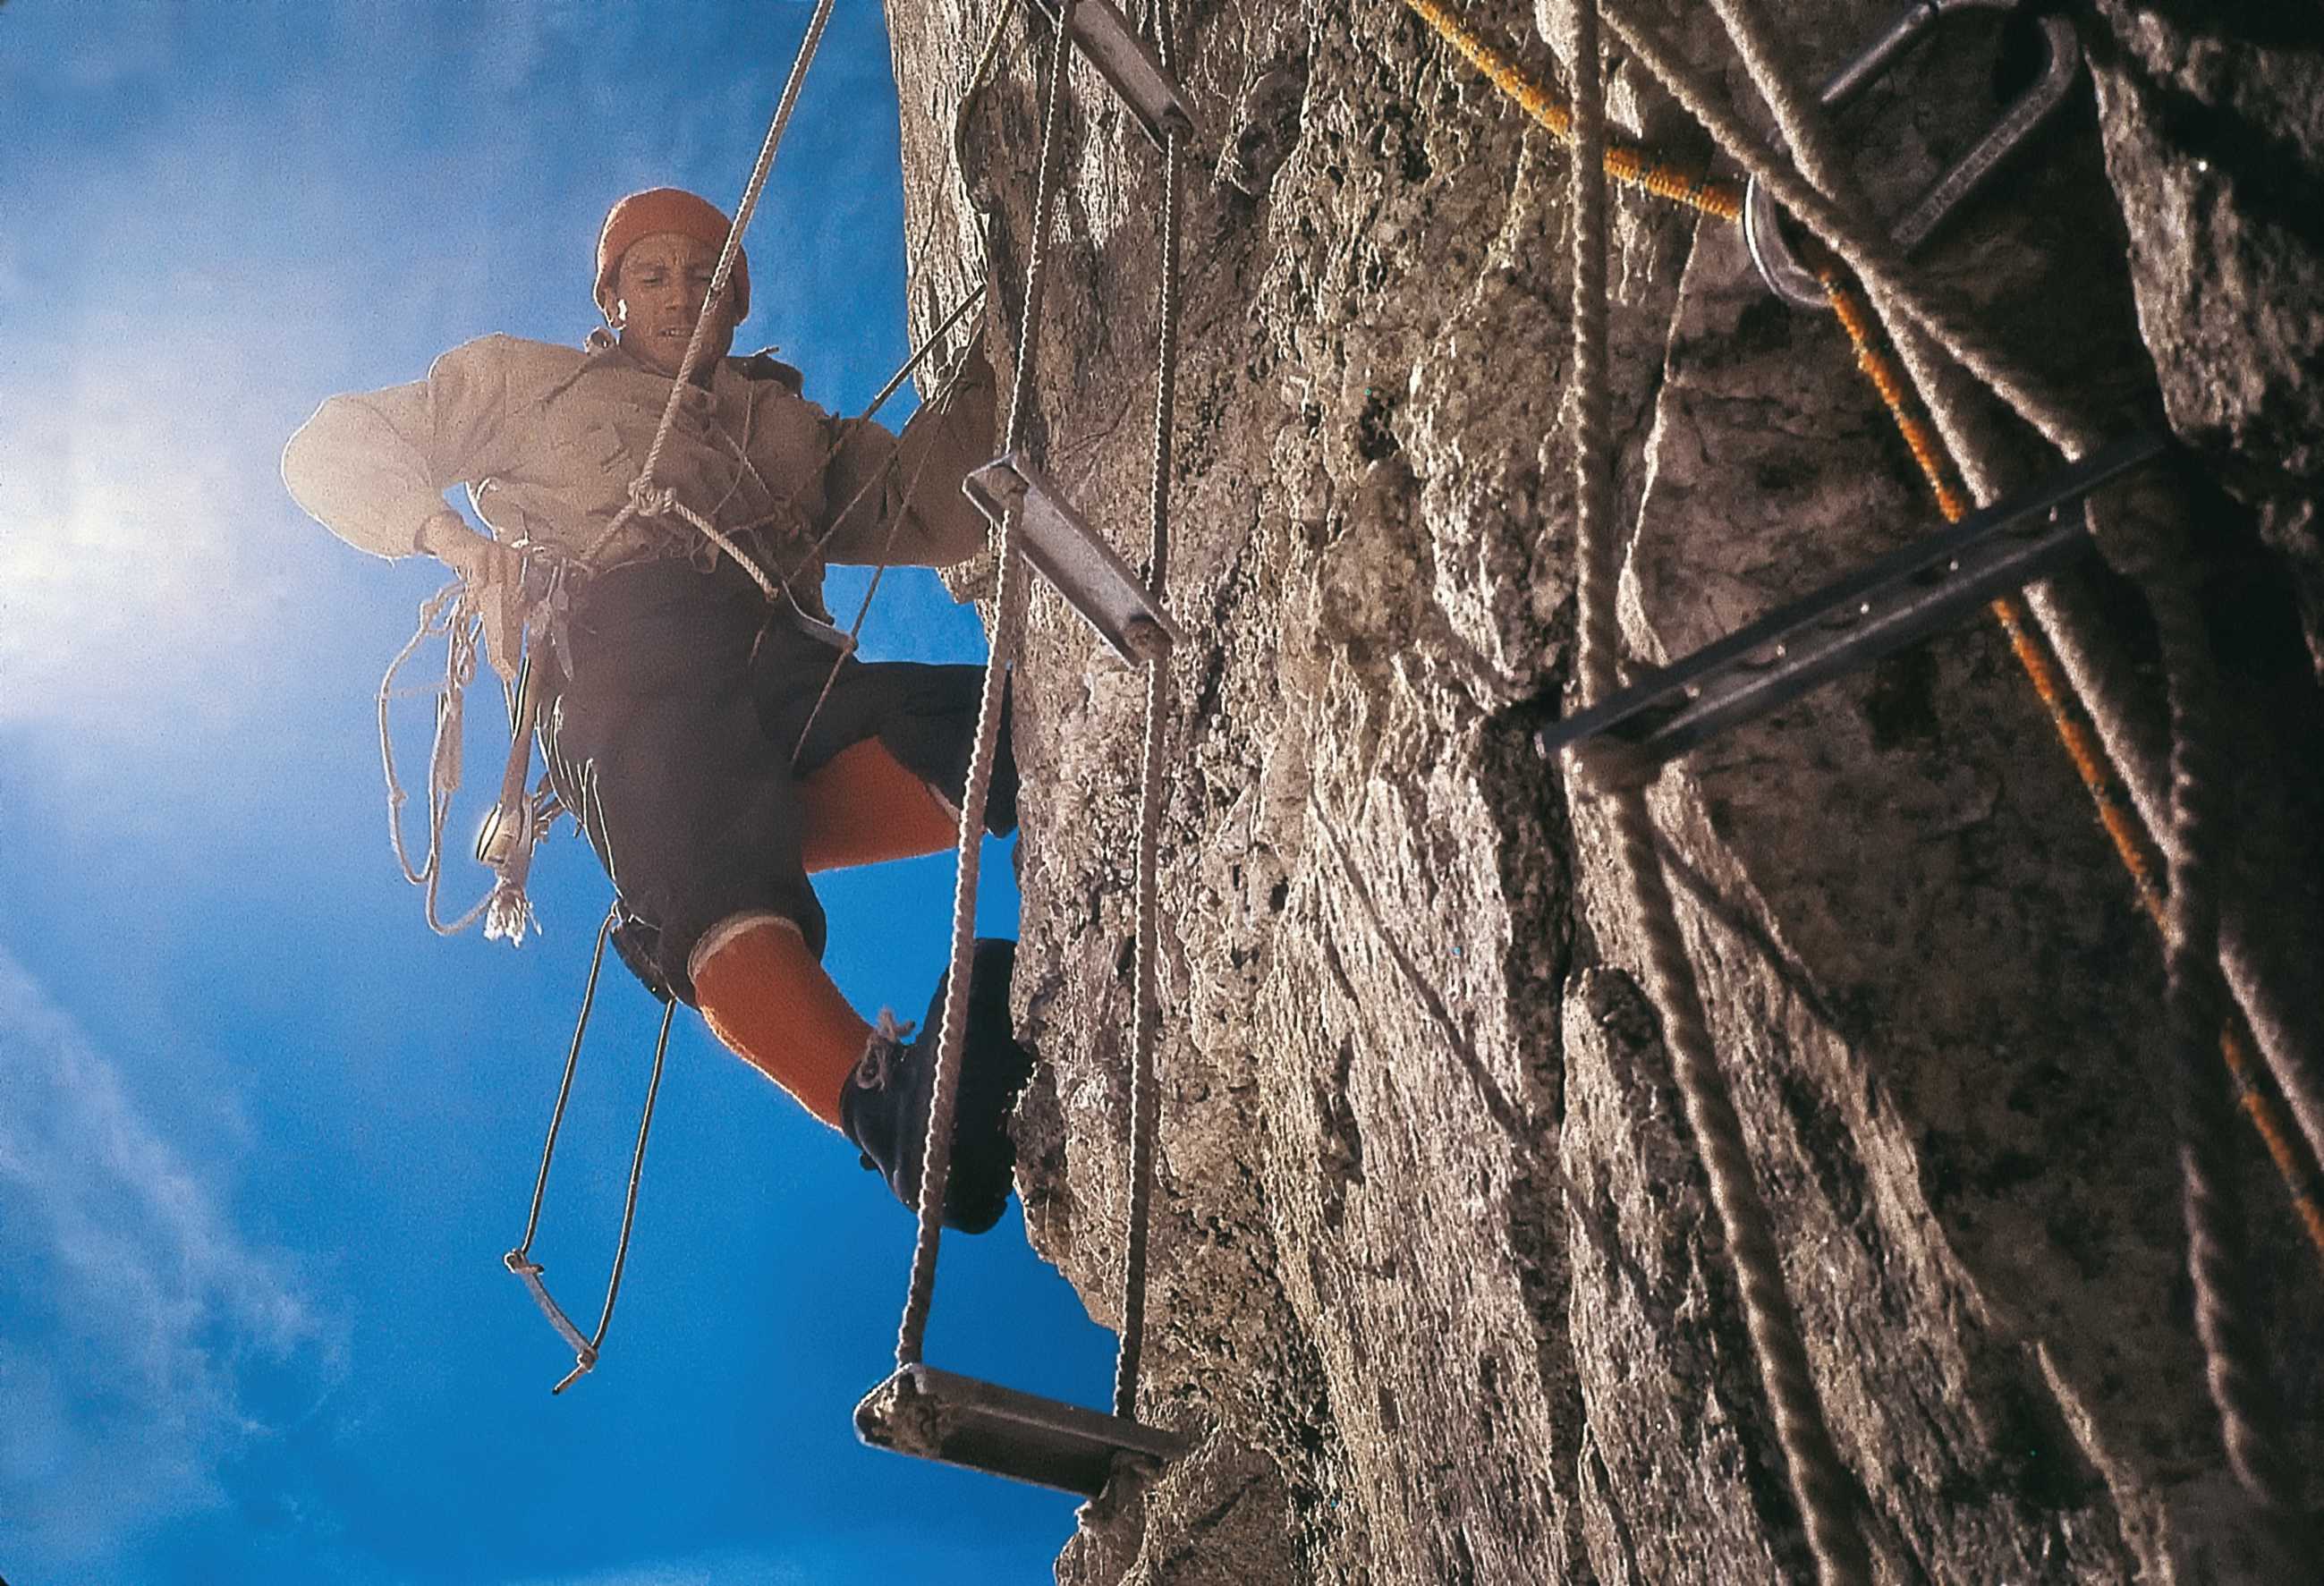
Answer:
284, 189, 1027, 1233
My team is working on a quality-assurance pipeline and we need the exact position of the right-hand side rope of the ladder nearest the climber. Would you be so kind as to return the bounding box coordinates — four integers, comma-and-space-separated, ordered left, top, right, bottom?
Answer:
1113, 0, 1181, 1421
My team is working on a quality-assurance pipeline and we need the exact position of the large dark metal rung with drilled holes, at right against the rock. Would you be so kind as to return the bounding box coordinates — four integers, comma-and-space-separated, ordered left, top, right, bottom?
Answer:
1534, 435, 2168, 768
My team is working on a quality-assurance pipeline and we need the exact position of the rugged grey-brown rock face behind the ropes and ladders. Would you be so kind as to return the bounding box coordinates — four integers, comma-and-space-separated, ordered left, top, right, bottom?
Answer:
890, 0, 2324, 1586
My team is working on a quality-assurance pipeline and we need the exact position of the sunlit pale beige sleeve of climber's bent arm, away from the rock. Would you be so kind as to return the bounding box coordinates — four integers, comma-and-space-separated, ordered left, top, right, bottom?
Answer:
284, 337, 525, 556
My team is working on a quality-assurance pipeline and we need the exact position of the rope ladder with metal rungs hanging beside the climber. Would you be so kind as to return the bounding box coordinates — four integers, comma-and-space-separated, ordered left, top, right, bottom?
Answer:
855, 0, 1192, 1500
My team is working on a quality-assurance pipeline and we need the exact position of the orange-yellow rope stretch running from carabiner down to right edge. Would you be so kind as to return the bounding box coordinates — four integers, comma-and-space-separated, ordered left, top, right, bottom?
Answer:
1818, 267, 2324, 1256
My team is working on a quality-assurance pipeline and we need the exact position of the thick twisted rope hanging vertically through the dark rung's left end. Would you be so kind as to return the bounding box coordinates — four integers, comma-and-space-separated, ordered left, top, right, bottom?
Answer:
1571, 0, 1870, 1586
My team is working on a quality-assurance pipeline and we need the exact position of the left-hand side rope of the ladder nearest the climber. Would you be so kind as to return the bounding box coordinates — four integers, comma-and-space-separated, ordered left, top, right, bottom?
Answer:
895, 0, 1073, 1365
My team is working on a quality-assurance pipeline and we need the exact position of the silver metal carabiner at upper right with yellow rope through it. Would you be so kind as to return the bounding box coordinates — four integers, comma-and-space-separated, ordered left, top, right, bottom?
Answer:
1743, 0, 2082, 310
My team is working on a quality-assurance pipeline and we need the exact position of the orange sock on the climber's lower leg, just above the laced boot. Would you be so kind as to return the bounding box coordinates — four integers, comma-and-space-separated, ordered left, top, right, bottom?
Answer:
691, 914, 871, 1128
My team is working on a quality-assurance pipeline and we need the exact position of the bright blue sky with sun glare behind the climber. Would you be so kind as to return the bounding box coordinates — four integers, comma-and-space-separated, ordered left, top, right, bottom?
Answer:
0, 0, 1111, 1586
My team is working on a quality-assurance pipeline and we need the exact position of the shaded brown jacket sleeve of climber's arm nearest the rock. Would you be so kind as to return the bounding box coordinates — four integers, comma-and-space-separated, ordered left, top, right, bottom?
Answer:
823, 367, 992, 567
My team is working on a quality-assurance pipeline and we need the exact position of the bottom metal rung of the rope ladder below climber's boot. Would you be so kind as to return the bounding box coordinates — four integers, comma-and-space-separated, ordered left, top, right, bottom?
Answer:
855, 1365, 1185, 1497
